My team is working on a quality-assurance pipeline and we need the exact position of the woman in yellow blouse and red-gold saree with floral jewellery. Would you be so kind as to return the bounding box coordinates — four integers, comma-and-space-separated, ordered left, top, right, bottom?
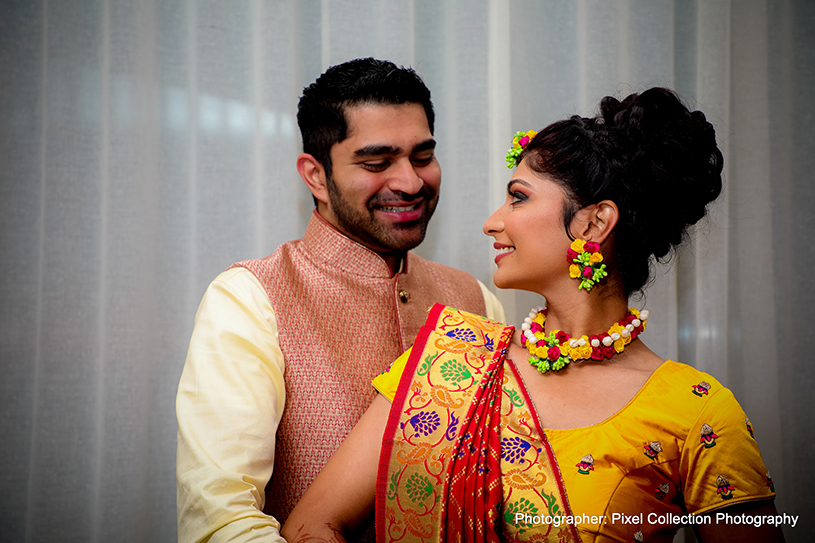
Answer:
283, 88, 783, 542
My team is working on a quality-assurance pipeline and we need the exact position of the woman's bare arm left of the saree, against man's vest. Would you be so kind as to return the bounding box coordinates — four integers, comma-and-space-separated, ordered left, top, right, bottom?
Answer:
280, 394, 391, 543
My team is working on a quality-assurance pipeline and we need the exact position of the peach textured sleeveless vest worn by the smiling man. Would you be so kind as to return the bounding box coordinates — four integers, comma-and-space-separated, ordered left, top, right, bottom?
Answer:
230, 212, 486, 523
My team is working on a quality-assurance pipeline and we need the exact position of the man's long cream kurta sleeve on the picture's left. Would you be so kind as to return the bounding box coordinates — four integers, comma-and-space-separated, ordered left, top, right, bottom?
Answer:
176, 268, 285, 543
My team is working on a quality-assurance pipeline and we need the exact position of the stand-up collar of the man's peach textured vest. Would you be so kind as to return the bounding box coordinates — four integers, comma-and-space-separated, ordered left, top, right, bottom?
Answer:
302, 209, 410, 279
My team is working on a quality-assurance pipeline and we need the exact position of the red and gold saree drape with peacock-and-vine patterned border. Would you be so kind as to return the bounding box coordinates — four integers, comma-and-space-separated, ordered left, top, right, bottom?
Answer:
376, 304, 580, 543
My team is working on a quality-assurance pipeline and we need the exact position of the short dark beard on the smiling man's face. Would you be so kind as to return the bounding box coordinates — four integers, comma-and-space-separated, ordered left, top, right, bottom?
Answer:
326, 176, 438, 251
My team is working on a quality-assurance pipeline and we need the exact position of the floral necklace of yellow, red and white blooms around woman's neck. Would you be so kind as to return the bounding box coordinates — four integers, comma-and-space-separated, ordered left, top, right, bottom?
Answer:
521, 307, 648, 373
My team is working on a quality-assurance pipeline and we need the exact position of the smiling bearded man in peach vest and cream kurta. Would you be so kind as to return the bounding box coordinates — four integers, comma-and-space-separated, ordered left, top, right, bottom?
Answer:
177, 59, 503, 543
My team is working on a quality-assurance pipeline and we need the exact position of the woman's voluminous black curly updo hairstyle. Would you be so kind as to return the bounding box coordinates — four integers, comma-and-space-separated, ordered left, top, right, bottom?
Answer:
521, 88, 724, 297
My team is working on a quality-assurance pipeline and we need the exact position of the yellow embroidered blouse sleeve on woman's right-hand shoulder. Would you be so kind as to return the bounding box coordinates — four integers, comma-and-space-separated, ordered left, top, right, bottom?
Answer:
681, 387, 775, 514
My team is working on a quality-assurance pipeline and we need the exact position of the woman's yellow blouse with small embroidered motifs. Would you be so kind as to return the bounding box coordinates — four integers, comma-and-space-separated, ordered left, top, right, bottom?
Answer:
373, 353, 775, 543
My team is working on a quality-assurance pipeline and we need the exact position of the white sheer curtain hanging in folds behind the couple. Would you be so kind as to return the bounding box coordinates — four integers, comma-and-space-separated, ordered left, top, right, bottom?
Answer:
0, 0, 815, 542
